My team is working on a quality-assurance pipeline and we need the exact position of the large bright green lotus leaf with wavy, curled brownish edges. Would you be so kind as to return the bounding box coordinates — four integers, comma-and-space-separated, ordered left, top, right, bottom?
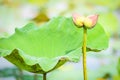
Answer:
0, 17, 108, 73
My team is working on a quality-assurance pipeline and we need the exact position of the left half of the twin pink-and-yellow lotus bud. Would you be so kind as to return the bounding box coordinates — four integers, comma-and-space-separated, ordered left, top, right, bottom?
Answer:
72, 14, 85, 28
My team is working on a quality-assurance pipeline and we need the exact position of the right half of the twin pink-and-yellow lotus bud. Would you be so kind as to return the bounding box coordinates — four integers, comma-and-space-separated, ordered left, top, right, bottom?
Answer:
84, 15, 98, 28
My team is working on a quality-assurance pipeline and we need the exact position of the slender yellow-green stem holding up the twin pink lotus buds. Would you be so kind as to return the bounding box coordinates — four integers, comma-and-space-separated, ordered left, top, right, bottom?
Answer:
82, 28, 87, 80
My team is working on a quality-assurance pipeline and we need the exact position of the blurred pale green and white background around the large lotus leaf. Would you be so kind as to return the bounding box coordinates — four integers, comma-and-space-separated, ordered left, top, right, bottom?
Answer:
0, 0, 120, 80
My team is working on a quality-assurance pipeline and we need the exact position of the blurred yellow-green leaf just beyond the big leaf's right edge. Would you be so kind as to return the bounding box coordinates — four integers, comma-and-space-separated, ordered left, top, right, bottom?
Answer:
99, 12, 119, 35
